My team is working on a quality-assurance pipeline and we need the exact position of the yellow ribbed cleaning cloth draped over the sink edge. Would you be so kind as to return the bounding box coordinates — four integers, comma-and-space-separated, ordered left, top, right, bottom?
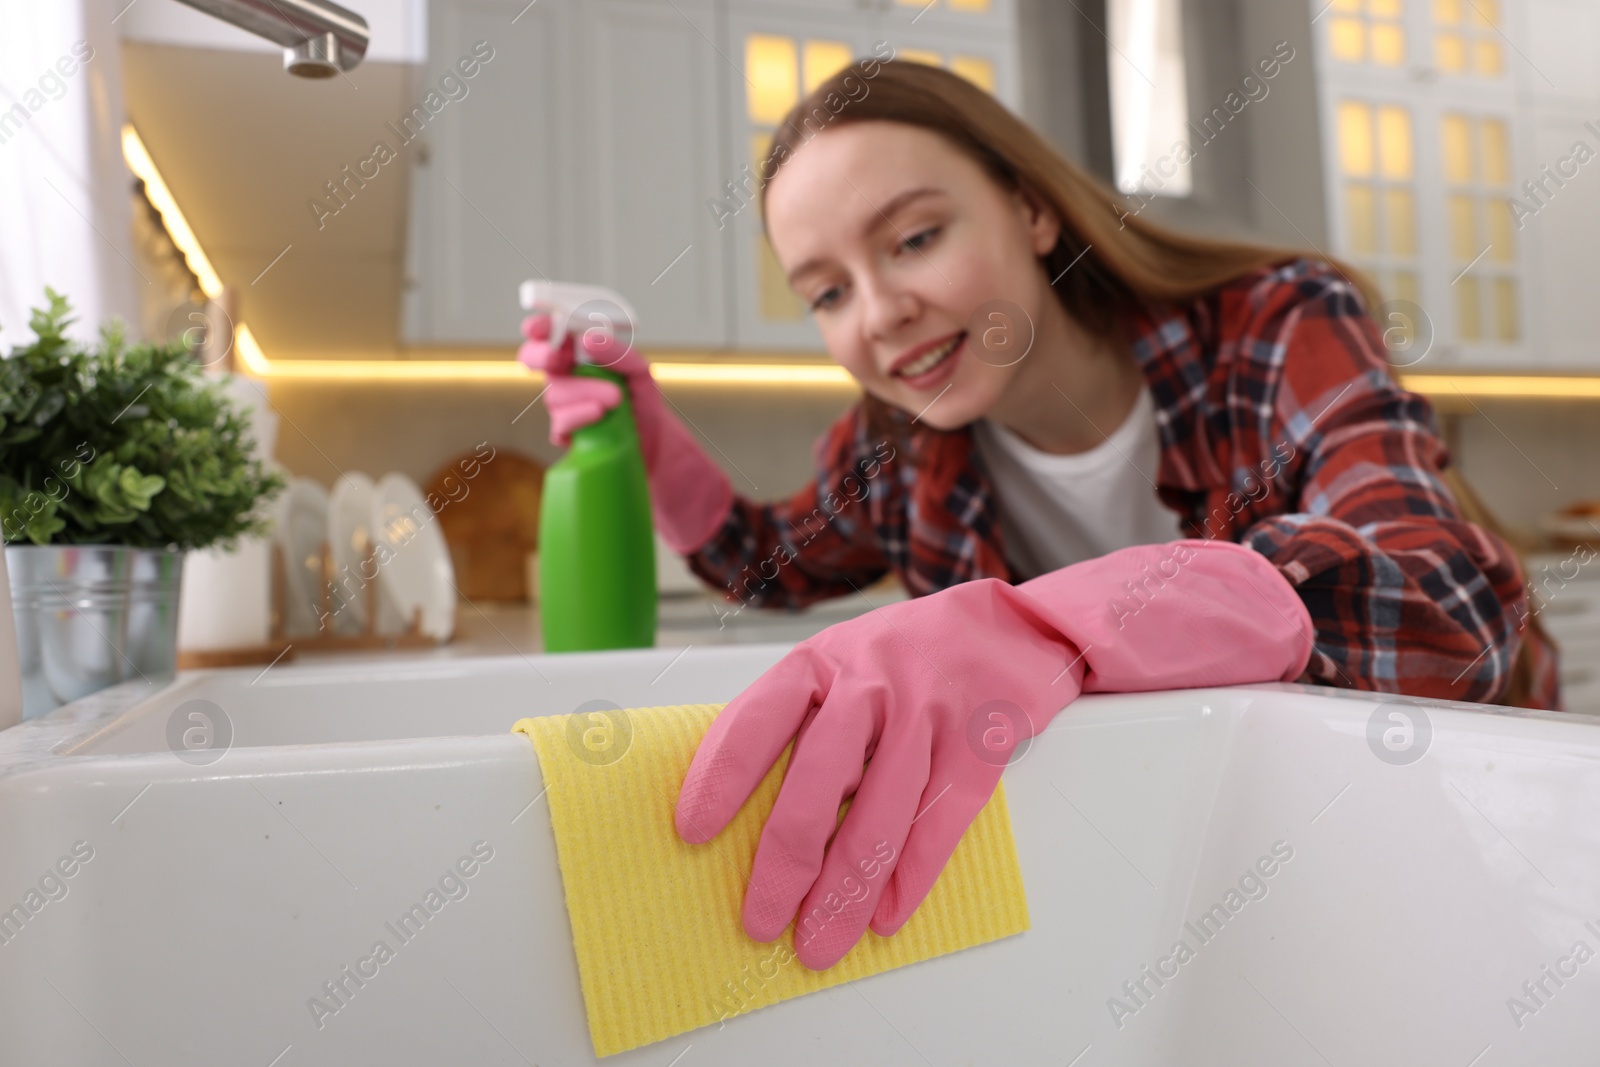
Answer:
512, 704, 1029, 1056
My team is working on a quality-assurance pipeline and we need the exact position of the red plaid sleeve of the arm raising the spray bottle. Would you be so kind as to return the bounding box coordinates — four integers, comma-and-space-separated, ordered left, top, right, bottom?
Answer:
685, 403, 893, 611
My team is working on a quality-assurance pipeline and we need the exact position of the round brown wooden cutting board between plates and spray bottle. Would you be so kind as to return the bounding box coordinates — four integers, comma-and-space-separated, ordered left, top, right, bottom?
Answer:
426, 446, 544, 601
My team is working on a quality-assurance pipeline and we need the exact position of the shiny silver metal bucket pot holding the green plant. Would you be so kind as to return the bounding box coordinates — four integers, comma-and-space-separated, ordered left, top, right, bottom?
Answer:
5, 545, 182, 718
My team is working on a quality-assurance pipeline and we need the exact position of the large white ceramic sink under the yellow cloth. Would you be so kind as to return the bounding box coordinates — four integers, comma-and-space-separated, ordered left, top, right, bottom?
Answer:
0, 645, 1600, 1067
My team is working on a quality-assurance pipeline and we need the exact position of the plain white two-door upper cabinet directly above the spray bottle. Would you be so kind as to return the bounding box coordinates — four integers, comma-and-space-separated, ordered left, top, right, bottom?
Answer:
406, 0, 728, 346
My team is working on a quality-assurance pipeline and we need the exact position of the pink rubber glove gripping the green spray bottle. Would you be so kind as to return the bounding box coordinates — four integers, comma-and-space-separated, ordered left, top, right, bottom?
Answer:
517, 312, 733, 555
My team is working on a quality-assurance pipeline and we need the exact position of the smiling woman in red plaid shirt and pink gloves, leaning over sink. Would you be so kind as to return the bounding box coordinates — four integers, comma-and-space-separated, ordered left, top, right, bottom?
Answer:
522, 61, 1555, 968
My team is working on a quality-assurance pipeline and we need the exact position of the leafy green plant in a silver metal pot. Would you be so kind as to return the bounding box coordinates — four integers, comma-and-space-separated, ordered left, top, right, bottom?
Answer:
0, 290, 283, 717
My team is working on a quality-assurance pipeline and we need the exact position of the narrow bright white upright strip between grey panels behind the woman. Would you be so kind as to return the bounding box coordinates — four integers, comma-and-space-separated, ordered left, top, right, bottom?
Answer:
1106, 0, 1194, 197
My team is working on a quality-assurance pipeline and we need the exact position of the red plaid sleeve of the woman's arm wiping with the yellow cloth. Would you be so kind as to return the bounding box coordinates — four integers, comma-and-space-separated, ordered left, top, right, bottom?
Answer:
1238, 270, 1555, 704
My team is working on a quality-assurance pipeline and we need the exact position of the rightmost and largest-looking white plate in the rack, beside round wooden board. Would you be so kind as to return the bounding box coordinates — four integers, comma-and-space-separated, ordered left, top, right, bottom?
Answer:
371, 474, 456, 641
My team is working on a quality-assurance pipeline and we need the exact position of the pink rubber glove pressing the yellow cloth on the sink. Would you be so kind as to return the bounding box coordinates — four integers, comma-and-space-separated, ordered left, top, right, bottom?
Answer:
675, 541, 1312, 969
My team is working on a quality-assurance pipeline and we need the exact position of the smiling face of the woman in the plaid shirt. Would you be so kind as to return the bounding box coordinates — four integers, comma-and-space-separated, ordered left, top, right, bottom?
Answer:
766, 120, 1061, 429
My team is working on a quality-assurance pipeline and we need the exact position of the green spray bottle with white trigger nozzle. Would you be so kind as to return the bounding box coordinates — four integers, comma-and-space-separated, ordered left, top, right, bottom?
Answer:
520, 282, 656, 653
